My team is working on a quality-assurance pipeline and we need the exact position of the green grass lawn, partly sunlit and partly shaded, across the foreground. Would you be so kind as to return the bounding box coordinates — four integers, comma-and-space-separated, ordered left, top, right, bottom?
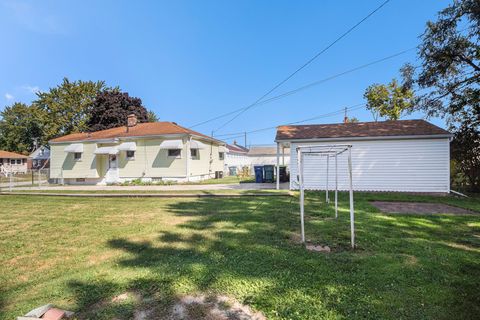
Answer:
0, 193, 480, 319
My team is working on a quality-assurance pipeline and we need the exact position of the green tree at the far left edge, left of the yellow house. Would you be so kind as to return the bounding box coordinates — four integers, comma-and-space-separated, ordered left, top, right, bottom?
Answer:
0, 102, 44, 154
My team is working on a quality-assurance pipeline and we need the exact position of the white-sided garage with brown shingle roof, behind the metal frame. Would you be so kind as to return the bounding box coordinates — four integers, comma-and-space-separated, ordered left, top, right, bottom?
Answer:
275, 120, 452, 192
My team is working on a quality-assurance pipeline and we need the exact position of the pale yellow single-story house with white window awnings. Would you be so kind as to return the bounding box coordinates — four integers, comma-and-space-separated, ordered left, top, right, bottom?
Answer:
49, 115, 226, 184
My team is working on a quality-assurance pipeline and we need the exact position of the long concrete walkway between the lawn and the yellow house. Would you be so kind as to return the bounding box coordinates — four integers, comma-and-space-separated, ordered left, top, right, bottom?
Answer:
9, 183, 289, 191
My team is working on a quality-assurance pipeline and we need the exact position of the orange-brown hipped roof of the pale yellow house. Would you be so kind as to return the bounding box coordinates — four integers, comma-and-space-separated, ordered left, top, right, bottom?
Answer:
50, 121, 222, 143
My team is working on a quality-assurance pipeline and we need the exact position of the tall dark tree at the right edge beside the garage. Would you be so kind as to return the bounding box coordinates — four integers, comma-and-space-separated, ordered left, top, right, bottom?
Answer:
415, 0, 480, 190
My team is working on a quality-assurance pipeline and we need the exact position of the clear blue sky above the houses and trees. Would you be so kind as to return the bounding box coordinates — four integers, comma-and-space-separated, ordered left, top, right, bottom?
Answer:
0, 0, 449, 144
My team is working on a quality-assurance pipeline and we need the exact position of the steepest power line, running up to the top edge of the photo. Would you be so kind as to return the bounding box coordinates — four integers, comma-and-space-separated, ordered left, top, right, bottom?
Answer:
214, 0, 390, 131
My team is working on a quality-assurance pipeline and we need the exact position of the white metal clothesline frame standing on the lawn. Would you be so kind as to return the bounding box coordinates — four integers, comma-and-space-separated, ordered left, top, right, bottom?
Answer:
296, 144, 355, 248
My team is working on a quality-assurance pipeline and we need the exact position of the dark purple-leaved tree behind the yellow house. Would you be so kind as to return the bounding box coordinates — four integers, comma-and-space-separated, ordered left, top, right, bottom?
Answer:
87, 89, 148, 131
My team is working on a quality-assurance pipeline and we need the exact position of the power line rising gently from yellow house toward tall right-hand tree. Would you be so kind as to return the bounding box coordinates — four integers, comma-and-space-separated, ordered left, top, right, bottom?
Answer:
189, 47, 417, 128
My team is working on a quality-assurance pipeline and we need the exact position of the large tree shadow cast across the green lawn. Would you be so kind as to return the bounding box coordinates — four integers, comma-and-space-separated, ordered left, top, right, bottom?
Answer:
66, 193, 480, 319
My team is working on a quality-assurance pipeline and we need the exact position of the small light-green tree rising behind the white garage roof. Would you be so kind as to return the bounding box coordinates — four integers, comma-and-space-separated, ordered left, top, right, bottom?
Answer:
363, 74, 415, 121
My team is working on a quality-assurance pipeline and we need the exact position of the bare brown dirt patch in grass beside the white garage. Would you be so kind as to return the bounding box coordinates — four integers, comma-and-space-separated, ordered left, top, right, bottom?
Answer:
370, 201, 474, 215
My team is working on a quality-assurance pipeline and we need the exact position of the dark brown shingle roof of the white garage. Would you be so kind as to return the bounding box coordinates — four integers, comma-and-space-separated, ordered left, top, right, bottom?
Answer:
275, 120, 451, 141
